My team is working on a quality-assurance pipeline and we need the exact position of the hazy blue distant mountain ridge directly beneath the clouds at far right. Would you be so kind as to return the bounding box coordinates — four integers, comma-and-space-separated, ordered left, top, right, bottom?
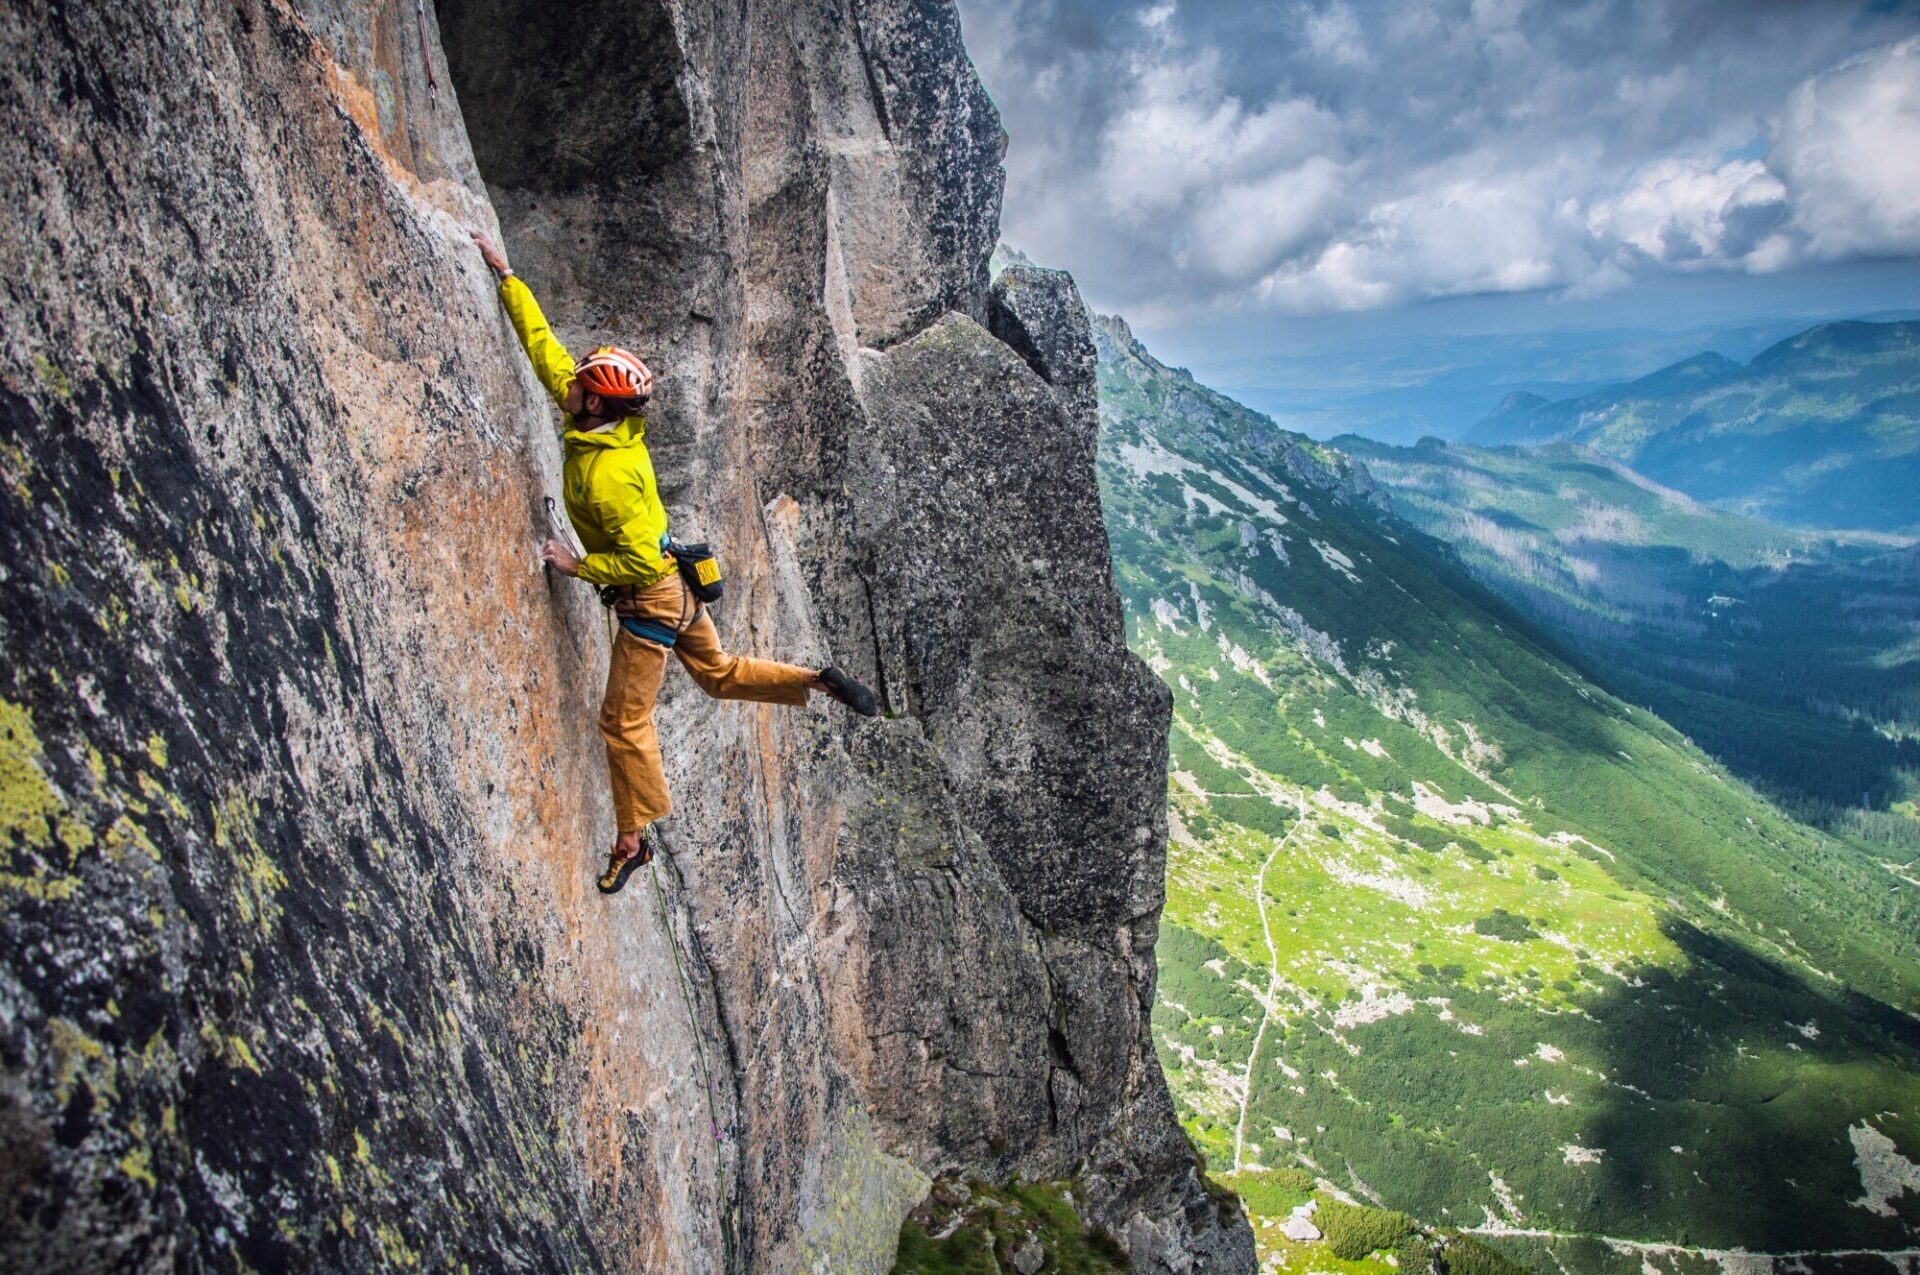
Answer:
1461, 319, 1920, 532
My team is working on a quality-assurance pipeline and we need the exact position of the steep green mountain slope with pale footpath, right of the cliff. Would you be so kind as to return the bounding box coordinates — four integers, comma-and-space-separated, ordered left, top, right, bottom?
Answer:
1096, 311, 1920, 1271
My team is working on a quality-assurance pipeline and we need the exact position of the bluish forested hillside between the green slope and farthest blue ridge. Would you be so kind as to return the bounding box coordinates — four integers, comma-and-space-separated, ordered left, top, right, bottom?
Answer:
1336, 436, 1920, 817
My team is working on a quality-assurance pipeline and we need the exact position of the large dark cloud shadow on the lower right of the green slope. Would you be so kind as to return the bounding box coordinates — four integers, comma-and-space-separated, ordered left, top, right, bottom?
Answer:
1584, 920, 1920, 1252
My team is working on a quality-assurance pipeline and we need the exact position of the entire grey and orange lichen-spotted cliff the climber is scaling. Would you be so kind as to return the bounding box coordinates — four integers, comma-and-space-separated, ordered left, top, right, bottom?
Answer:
0, 0, 1252, 1273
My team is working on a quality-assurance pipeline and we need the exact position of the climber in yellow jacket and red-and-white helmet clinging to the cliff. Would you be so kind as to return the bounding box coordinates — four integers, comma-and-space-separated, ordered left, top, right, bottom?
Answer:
468, 230, 879, 895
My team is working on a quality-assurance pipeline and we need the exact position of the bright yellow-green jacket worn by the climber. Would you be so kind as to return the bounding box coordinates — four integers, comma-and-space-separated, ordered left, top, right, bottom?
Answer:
499, 275, 674, 586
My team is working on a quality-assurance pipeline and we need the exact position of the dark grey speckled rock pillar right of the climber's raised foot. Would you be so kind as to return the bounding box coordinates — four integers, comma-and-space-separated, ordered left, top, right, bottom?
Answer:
851, 315, 1212, 1269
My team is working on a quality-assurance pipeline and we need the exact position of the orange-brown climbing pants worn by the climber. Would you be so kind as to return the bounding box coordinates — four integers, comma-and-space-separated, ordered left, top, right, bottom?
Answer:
601, 572, 814, 833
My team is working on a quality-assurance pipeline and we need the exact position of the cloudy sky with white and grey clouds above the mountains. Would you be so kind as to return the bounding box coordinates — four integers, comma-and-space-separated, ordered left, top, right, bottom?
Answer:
960, 0, 1920, 323
